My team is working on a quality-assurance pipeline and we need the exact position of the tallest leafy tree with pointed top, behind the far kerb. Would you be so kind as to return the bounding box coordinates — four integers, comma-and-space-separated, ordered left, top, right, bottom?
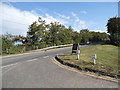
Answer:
27, 17, 47, 49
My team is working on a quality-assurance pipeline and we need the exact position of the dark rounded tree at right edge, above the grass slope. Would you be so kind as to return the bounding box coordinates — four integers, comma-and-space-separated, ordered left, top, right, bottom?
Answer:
106, 17, 120, 46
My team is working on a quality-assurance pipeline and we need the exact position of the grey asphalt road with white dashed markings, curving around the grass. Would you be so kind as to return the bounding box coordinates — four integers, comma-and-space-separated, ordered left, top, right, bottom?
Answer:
2, 46, 118, 88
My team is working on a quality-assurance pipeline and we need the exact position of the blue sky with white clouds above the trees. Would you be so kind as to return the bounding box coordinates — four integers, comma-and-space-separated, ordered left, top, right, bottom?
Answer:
0, 2, 118, 36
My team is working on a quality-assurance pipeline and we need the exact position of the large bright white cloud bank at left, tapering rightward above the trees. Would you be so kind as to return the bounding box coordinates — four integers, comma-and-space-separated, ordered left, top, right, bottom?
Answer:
0, 4, 67, 36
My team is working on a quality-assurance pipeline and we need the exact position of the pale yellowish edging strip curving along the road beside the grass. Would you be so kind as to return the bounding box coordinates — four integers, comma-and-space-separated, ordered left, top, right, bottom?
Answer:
52, 54, 118, 83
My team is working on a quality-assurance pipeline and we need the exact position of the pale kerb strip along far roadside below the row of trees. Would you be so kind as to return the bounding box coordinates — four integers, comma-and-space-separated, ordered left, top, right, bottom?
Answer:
0, 44, 72, 58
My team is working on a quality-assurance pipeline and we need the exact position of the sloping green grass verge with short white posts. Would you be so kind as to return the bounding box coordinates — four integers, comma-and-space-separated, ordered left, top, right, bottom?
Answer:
61, 45, 118, 74
